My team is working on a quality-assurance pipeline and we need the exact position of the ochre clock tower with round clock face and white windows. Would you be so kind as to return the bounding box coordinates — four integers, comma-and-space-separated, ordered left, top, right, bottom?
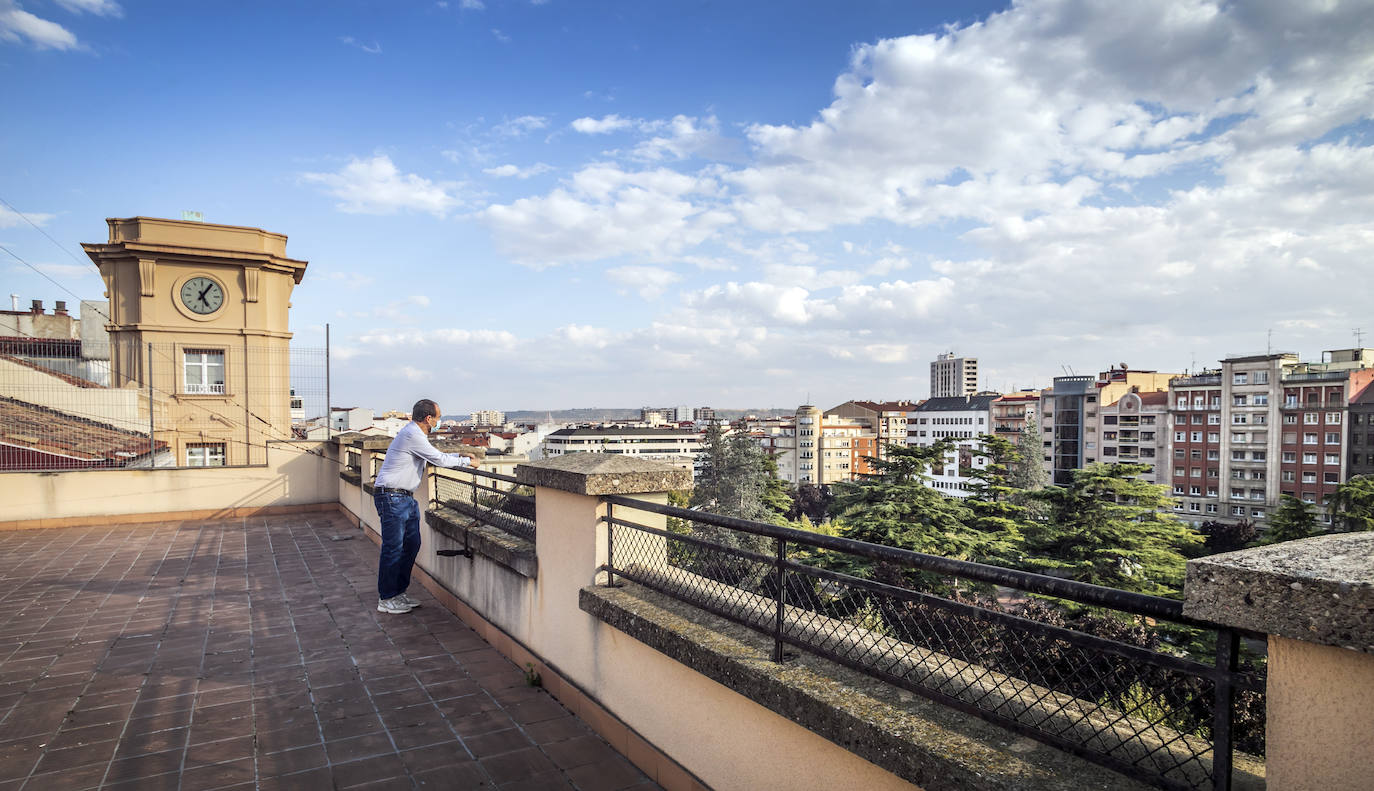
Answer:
81, 217, 306, 466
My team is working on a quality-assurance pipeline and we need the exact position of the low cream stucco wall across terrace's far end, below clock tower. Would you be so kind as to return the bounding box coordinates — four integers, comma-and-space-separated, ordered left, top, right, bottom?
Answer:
0, 442, 339, 526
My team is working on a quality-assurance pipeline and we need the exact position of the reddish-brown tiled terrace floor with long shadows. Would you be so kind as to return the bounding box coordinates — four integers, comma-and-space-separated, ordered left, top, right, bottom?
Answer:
0, 514, 657, 791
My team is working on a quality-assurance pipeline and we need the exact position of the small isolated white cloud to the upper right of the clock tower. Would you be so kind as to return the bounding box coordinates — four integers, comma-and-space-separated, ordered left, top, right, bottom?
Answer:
301, 154, 463, 217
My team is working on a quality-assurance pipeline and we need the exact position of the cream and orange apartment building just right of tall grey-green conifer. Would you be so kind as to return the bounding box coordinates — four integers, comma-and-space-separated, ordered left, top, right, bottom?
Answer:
760, 404, 878, 485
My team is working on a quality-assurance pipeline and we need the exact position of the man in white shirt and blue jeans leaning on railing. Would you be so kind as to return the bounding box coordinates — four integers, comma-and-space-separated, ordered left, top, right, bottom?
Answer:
372, 398, 477, 614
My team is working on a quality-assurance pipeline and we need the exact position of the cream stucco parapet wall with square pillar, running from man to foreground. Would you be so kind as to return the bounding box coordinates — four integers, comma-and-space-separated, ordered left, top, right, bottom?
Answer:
341, 475, 914, 791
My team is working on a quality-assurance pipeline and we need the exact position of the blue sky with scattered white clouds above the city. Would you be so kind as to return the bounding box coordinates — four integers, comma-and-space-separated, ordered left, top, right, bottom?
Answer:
0, 0, 1374, 413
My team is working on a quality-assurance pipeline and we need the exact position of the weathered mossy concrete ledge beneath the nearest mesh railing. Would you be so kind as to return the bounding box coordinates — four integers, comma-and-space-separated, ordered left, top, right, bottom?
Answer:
578, 582, 1149, 791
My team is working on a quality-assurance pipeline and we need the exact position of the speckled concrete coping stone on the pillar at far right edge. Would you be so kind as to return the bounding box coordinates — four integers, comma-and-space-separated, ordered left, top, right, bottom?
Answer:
1183, 533, 1374, 654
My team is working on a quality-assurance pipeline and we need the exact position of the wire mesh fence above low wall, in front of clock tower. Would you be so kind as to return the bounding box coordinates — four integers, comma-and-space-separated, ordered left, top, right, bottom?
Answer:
0, 338, 327, 470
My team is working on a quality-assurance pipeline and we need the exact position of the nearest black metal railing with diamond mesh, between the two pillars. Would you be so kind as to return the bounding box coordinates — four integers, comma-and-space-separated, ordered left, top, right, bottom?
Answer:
602, 496, 1264, 790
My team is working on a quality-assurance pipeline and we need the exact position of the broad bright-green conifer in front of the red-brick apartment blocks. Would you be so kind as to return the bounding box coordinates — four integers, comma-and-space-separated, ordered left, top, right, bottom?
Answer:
1024, 464, 1202, 596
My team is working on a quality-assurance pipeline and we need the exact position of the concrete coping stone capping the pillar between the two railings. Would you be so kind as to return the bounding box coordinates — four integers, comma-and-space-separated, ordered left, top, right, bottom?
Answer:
515, 453, 691, 494
